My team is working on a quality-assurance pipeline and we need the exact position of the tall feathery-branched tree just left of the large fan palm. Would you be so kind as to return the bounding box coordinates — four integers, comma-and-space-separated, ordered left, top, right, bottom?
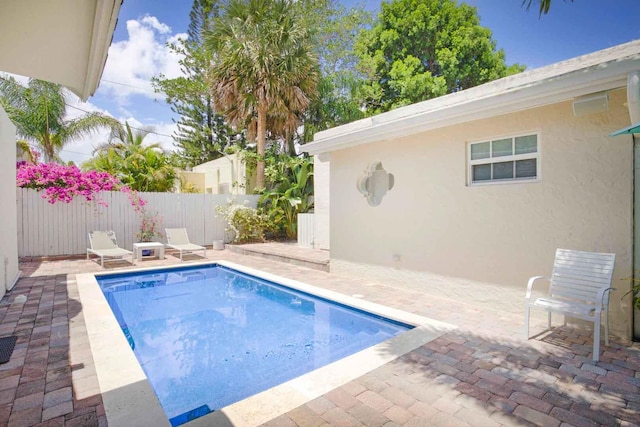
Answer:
152, 0, 244, 171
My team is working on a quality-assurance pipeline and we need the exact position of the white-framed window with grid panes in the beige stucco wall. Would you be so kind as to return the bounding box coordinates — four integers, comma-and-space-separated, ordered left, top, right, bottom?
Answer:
468, 134, 540, 185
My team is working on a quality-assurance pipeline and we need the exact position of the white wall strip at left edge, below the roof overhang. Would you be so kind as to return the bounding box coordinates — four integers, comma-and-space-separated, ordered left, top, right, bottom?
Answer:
0, 107, 19, 298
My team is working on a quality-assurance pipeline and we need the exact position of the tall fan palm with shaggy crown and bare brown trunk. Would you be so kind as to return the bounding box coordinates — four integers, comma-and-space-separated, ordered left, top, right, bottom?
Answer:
205, 0, 318, 189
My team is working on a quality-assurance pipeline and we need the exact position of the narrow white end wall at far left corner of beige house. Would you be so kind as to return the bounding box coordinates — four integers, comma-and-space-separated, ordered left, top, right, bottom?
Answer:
313, 154, 331, 250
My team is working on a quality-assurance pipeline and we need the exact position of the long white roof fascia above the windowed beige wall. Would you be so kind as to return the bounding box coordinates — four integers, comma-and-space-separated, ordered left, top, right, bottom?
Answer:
301, 40, 640, 154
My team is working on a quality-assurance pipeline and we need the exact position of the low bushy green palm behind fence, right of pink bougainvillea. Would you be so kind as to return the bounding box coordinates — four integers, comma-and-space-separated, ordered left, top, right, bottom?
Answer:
82, 123, 176, 192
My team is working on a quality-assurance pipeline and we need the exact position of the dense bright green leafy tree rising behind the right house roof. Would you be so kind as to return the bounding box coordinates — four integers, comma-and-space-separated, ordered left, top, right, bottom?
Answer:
356, 0, 524, 114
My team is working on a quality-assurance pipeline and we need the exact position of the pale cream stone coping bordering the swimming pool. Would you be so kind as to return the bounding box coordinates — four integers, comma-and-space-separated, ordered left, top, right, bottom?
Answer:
76, 260, 456, 427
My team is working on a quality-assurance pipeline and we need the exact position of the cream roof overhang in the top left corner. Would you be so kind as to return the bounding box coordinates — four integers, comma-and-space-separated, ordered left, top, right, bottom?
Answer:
0, 0, 122, 100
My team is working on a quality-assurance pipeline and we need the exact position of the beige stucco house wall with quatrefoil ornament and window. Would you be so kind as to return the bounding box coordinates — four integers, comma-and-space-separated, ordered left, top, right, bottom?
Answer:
330, 89, 632, 338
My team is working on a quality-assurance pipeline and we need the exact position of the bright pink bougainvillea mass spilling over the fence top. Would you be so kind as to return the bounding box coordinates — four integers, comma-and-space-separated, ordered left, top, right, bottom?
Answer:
16, 162, 122, 205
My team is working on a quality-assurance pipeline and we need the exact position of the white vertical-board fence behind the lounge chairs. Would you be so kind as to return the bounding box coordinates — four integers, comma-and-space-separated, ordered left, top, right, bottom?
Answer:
17, 188, 258, 257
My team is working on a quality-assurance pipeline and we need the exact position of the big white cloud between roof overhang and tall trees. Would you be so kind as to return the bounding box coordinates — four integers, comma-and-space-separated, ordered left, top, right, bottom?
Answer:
100, 15, 187, 106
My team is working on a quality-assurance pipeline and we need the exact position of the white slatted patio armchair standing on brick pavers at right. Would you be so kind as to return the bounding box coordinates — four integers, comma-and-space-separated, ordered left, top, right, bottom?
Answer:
524, 249, 616, 362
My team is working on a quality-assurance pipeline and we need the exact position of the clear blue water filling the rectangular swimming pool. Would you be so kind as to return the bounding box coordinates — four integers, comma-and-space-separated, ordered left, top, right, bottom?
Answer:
96, 264, 412, 426
